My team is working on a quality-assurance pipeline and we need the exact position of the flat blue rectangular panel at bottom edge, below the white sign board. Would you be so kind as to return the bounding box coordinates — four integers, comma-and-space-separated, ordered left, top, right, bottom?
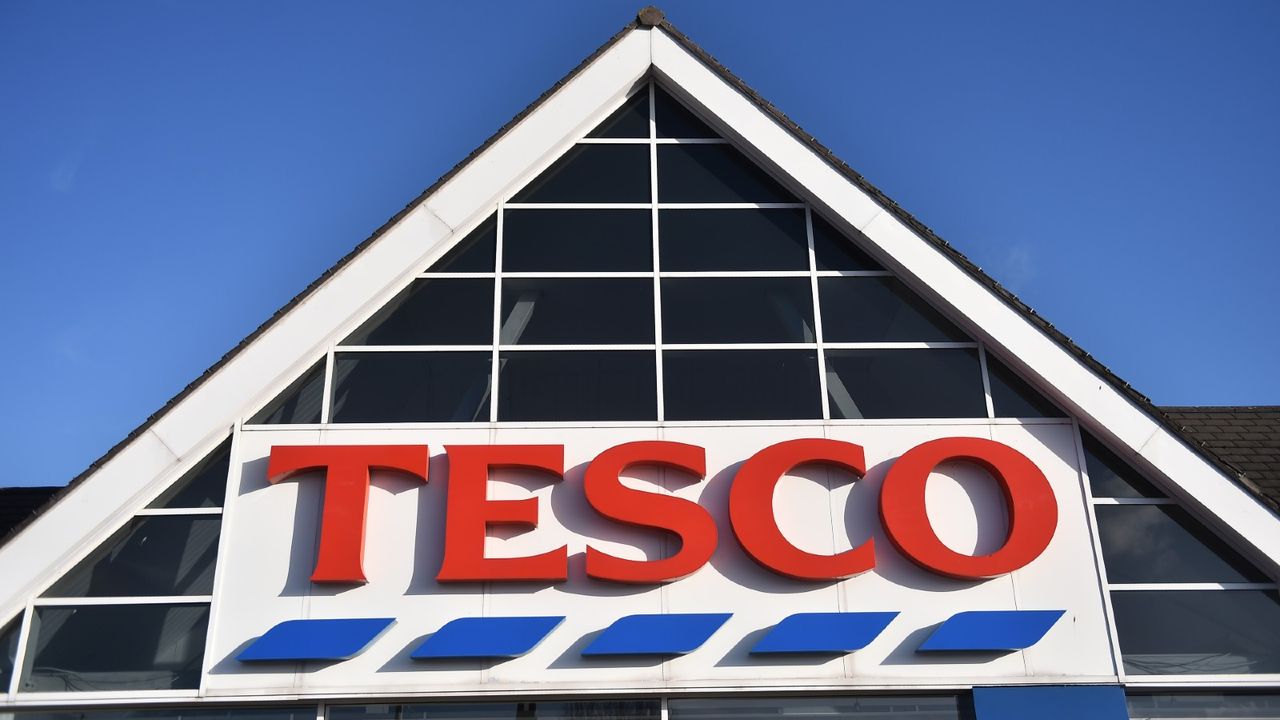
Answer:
973, 685, 1129, 720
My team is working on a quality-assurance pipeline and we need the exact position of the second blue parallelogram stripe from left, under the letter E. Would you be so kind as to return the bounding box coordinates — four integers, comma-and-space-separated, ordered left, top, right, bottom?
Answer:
410, 615, 564, 660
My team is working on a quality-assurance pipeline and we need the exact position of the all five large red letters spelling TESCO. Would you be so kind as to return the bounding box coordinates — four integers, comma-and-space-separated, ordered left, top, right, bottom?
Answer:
268, 437, 1059, 584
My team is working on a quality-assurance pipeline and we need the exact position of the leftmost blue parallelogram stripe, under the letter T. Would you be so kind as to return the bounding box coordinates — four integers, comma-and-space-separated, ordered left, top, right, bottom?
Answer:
236, 618, 396, 662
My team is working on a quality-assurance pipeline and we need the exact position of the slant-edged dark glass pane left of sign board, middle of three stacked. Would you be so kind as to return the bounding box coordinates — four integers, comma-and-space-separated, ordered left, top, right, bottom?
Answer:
45, 515, 221, 597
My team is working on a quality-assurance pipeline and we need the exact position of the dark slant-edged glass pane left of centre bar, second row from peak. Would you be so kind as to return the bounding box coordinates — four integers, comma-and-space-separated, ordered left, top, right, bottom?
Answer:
512, 145, 653, 202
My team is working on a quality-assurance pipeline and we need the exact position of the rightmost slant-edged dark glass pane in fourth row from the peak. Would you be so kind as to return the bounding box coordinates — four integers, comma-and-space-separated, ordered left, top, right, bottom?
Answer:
818, 277, 967, 340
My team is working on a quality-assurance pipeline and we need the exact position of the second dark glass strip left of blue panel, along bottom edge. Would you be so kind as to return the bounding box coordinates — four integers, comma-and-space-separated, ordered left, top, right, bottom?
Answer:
329, 700, 660, 720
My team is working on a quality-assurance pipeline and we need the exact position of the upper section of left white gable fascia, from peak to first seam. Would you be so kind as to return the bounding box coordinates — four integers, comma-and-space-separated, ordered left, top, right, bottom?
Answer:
426, 29, 650, 228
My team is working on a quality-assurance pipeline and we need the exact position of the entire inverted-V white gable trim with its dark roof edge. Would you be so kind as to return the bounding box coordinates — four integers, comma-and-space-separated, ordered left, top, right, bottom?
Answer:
0, 6, 1280, 611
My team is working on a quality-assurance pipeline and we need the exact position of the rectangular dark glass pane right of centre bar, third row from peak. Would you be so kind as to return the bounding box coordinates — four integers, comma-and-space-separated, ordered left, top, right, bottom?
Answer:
658, 209, 809, 273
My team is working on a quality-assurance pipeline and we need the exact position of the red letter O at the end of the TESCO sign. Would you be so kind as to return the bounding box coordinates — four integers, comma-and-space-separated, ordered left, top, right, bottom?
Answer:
879, 430, 1057, 580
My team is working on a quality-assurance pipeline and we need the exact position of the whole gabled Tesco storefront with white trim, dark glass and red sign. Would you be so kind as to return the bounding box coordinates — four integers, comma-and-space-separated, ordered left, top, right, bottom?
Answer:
0, 12, 1280, 720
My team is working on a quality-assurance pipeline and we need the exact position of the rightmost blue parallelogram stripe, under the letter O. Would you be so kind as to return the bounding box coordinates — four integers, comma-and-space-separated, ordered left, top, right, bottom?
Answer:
919, 610, 1066, 652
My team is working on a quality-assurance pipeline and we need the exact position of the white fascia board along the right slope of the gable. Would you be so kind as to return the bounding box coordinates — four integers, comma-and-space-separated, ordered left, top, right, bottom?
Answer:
653, 31, 1280, 573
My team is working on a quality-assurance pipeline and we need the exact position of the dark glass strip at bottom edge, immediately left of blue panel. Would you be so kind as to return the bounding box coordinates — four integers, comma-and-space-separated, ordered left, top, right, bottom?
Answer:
667, 694, 972, 720
